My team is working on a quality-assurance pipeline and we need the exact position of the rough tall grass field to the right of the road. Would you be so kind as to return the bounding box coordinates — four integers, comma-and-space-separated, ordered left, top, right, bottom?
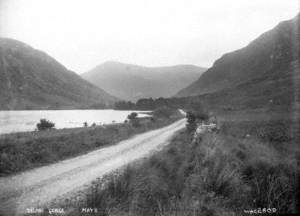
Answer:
72, 112, 300, 216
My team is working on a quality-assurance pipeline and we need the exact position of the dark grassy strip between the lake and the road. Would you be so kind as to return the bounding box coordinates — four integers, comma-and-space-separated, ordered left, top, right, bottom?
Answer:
0, 107, 181, 176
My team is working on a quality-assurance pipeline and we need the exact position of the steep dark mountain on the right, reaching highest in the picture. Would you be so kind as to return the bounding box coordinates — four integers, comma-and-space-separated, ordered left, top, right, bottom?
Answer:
176, 15, 300, 99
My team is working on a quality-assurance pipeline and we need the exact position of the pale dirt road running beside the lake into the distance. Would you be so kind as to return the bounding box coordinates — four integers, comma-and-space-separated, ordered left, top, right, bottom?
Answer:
0, 119, 185, 215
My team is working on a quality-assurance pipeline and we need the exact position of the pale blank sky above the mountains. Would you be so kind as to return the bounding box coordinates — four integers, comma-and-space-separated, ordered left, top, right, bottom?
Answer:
0, 0, 300, 73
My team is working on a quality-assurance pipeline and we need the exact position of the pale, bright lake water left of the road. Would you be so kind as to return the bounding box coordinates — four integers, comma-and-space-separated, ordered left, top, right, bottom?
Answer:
0, 110, 147, 134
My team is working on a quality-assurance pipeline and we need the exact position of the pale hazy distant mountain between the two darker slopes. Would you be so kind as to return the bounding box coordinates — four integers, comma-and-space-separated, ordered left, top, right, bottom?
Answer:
82, 61, 206, 101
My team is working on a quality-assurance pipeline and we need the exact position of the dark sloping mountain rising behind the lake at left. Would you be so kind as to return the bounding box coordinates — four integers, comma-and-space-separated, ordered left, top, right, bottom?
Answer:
0, 38, 117, 110
